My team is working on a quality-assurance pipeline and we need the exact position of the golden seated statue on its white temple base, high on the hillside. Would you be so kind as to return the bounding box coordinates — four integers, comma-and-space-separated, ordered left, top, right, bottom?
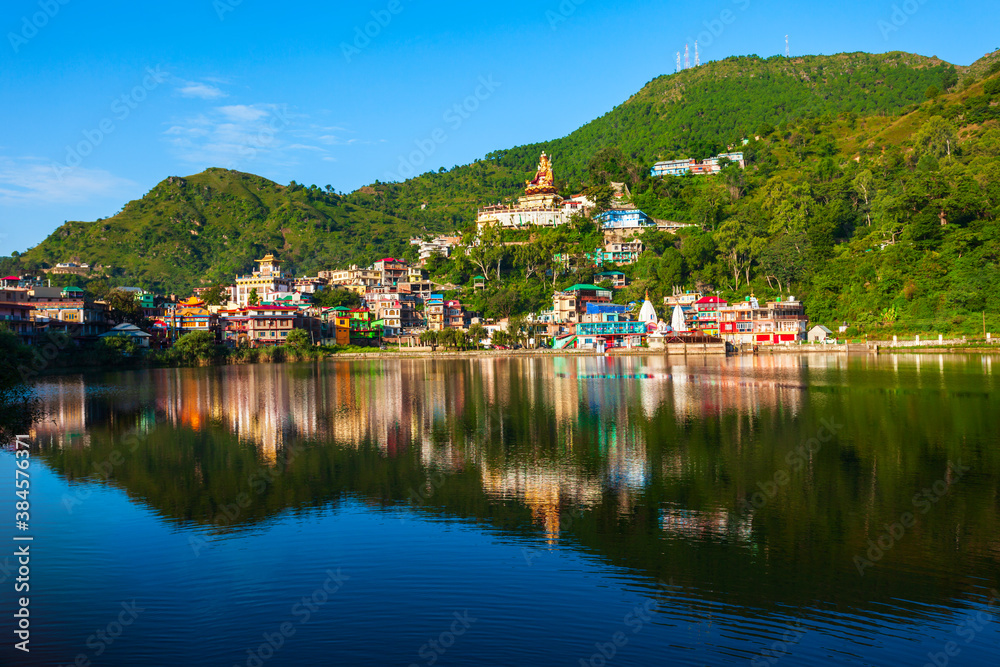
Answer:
477, 152, 593, 229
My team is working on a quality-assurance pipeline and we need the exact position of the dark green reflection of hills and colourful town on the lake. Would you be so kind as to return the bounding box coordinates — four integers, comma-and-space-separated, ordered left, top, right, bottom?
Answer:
33, 356, 1000, 607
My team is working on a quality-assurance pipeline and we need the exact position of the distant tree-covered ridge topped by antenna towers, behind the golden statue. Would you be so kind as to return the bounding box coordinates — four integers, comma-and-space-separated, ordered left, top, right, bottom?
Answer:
350, 52, 958, 223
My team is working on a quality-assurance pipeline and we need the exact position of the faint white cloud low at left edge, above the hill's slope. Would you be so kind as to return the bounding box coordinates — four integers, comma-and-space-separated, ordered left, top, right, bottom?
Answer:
0, 156, 137, 206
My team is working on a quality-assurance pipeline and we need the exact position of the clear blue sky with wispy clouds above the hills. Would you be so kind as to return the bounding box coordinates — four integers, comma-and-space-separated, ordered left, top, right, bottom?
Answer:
0, 0, 1000, 255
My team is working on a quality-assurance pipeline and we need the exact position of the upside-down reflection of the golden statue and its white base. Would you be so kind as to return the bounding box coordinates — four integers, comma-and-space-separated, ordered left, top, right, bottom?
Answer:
482, 463, 602, 542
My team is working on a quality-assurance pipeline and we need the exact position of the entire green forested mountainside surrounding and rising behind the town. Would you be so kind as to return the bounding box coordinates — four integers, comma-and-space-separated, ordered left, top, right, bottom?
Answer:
7, 53, 1000, 331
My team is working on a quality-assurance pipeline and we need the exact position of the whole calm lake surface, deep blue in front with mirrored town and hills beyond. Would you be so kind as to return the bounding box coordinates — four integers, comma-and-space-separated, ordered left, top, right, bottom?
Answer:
0, 355, 1000, 667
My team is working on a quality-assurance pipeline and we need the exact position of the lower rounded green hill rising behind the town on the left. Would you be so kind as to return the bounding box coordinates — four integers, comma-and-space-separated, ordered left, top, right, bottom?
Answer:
11, 169, 448, 294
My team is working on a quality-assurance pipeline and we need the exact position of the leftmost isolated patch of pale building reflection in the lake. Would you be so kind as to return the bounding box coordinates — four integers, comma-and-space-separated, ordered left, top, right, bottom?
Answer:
30, 376, 90, 449
